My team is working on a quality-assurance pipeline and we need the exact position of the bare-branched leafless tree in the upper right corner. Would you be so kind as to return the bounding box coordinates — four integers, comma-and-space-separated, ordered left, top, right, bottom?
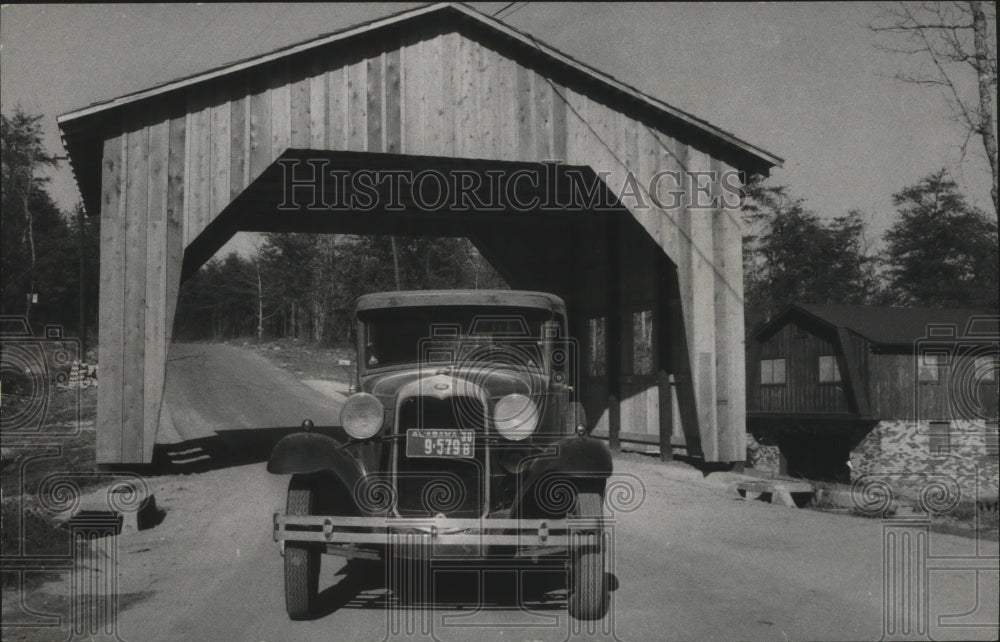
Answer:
869, 1, 1000, 216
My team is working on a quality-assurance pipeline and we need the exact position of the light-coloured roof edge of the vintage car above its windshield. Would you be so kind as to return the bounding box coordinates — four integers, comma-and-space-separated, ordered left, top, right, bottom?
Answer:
355, 290, 566, 315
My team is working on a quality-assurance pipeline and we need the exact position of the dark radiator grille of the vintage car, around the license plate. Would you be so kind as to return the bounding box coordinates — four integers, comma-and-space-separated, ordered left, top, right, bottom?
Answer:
395, 397, 489, 517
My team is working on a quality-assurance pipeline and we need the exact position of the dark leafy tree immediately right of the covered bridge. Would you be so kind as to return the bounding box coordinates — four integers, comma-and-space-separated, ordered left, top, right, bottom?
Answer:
743, 177, 878, 331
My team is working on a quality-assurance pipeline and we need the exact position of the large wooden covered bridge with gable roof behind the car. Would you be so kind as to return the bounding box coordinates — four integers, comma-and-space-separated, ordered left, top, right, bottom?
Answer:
59, 4, 781, 463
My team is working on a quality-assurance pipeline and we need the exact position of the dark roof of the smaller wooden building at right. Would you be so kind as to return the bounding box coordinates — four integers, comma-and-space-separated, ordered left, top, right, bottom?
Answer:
755, 303, 1000, 346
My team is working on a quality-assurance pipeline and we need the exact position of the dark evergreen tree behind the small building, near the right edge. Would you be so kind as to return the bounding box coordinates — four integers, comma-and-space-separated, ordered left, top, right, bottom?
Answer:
885, 169, 998, 309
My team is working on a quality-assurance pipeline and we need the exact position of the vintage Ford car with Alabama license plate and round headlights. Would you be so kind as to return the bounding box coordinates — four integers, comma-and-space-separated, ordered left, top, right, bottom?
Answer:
267, 290, 611, 619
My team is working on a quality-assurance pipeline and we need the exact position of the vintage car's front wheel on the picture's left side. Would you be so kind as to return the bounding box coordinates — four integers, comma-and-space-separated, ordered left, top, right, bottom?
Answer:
285, 476, 321, 620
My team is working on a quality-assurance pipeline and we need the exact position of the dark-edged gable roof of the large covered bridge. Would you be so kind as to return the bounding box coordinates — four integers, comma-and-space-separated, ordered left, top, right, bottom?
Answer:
57, 2, 784, 210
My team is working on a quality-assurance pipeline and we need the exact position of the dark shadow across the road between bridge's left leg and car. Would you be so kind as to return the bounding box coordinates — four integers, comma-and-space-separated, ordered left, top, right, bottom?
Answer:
142, 426, 345, 475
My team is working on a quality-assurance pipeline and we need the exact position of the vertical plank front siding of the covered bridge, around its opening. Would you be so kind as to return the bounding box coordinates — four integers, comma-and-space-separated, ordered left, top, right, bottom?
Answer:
99, 27, 743, 462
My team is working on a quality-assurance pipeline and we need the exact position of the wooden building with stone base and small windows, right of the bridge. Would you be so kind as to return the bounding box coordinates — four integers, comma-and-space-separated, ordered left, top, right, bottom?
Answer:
747, 304, 1000, 489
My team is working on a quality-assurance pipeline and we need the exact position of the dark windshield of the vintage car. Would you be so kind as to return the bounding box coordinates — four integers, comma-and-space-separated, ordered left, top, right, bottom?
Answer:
359, 306, 552, 369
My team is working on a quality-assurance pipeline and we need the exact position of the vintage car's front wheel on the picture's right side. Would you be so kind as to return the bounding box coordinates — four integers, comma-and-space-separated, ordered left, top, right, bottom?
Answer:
568, 493, 608, 620
